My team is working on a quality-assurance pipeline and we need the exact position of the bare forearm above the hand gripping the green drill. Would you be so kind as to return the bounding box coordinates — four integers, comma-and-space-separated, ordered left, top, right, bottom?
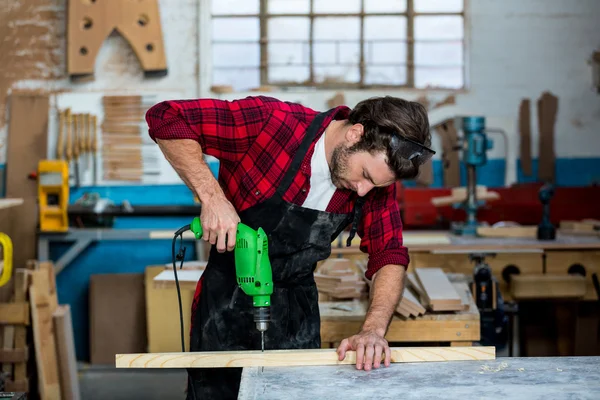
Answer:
157, 139, 223, 203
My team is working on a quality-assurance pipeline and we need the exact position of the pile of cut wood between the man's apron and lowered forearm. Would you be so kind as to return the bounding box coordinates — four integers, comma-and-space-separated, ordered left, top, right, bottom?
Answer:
314, 258, 367, 299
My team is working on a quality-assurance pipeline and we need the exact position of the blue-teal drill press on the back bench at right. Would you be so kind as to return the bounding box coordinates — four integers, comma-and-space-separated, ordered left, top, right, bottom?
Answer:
452, 117, 494, 236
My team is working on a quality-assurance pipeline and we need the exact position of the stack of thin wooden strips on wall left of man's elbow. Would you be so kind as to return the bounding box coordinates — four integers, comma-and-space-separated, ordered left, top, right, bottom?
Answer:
102, 96, 145, 182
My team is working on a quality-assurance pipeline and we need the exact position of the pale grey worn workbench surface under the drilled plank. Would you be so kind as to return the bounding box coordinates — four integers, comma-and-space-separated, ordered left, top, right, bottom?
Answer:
238, 357, 600, 400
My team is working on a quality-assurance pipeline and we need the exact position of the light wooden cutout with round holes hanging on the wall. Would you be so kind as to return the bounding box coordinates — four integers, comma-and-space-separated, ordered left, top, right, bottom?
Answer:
67, 0, 167, 79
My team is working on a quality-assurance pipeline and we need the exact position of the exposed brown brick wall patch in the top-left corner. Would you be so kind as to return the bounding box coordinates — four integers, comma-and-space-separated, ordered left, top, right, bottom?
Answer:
0, 0, 65, 136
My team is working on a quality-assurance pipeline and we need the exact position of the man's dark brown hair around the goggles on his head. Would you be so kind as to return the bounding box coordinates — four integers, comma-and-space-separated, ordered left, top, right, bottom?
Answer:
348, 96, 431, 179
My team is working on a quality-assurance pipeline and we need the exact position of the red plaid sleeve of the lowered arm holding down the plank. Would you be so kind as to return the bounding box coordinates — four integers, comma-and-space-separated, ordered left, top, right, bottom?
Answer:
357, 185, 410, 279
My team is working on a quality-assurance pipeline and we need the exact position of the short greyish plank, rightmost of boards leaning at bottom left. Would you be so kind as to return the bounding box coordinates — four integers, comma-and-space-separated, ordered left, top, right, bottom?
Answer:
53, 304, 81, 400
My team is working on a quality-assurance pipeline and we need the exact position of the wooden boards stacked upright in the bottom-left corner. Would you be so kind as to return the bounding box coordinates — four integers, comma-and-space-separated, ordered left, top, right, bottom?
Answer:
0, 261, 80, 400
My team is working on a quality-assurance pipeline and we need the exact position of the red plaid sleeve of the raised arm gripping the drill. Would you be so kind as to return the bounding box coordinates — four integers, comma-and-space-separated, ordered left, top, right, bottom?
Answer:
146, 97, 268, 161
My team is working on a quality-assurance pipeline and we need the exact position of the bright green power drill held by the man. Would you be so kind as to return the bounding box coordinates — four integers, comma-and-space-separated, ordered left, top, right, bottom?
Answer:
190, 217, 273, 351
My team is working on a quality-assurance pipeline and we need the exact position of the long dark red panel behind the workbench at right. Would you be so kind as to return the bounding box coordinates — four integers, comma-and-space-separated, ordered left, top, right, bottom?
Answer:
398, 183, 600, 229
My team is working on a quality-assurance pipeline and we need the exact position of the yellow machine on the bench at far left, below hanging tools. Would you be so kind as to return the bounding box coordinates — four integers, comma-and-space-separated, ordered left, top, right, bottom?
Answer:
37, 160, 69, 232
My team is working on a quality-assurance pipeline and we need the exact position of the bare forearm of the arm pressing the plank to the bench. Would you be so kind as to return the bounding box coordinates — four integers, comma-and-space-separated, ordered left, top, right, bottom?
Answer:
362, 264, 406, 336
